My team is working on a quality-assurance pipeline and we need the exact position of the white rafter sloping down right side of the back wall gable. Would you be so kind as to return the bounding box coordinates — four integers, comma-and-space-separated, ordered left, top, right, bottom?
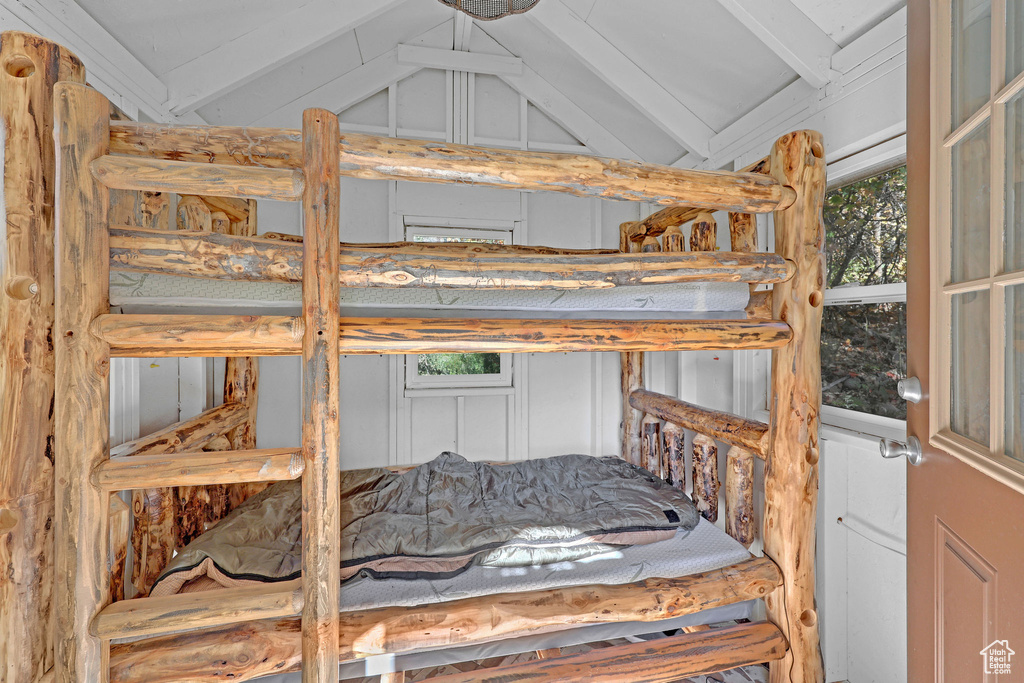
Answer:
473, 27, 642, 161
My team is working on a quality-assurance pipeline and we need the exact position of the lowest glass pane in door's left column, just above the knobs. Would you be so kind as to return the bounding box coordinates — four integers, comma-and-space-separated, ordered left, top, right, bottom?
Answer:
949, 290, 990, 446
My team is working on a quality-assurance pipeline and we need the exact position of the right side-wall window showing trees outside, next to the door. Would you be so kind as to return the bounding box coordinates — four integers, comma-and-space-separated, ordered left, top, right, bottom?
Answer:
821, 166, 906, 420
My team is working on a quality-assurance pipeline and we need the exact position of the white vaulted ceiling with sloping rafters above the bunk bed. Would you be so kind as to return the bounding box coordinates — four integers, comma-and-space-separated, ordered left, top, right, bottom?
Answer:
66, 0, 904, 163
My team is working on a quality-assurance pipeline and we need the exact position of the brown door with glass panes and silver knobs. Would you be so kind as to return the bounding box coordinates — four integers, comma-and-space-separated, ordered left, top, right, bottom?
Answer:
907, 0, 1024, 683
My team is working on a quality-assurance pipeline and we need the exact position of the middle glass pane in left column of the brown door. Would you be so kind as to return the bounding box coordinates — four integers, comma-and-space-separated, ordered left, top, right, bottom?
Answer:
951, 121, 990, 283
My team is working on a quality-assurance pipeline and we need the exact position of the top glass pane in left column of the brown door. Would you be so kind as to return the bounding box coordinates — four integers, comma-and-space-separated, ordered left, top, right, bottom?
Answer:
951, 0, 992, 129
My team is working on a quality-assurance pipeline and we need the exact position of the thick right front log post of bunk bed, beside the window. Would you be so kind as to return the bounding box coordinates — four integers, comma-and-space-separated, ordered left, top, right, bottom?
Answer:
763, 131, 825, 683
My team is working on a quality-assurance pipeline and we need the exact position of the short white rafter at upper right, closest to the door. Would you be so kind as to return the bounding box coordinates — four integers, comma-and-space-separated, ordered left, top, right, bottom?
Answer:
718, 0, 839, 88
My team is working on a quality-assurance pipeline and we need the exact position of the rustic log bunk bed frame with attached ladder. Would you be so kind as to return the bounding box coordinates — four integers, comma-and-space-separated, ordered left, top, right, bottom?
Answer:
0, 32, 825, 683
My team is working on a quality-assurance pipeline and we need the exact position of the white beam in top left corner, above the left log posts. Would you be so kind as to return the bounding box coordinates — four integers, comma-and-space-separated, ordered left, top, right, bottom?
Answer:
0, 0, 197, 123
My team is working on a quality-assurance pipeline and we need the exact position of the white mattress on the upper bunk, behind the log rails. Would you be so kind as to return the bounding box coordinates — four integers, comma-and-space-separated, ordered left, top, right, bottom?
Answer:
111, 270, 750, 317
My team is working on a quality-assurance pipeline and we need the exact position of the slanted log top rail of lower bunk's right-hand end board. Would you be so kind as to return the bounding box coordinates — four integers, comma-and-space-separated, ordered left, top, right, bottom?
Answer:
630, 389, 769, 458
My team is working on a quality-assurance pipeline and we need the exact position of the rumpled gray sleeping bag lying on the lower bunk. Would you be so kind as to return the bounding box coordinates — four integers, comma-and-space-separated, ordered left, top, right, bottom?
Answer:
152, 453, 698, 596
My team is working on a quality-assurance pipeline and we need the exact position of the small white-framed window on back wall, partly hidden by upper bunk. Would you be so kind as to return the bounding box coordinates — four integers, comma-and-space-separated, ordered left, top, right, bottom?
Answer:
406, 225, 512, 389
